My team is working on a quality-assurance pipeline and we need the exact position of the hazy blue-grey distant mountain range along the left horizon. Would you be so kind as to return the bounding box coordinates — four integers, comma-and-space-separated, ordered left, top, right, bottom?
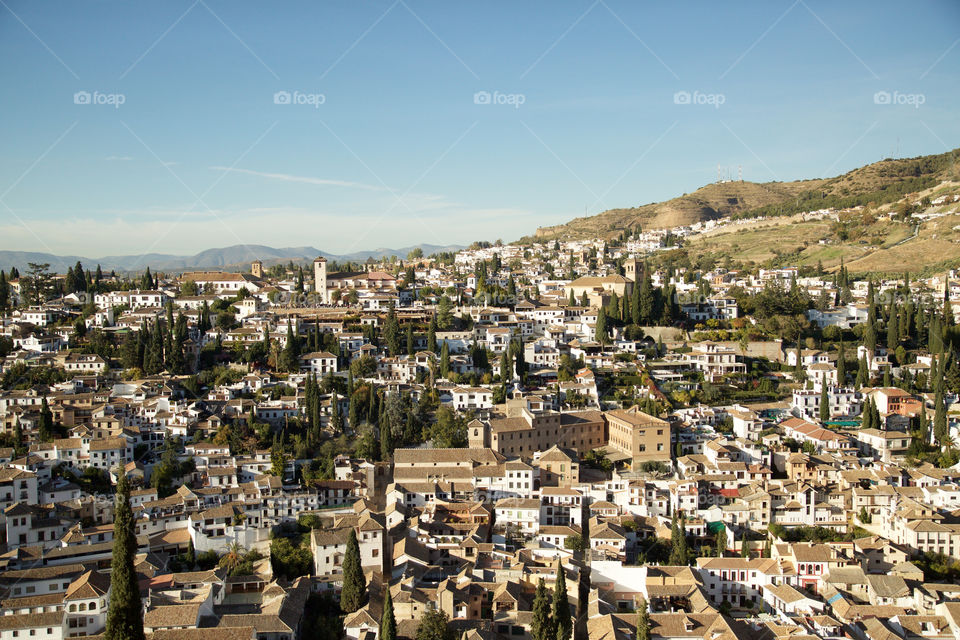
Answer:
0, 244, 463, 273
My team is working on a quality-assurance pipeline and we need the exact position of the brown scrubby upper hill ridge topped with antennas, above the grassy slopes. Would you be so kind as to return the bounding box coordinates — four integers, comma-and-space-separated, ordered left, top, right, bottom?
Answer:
534, 150, 960, 241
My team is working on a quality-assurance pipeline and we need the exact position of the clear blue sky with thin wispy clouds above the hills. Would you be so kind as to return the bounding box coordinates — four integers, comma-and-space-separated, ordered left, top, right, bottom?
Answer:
0, 0, 960, 257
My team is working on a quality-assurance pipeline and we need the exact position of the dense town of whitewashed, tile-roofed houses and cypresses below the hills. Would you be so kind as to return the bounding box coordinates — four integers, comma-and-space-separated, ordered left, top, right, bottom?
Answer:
0, 230, 960, 640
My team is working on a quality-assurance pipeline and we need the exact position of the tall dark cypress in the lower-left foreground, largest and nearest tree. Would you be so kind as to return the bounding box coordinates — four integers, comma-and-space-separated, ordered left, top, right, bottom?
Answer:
104, 472, 144, 640
